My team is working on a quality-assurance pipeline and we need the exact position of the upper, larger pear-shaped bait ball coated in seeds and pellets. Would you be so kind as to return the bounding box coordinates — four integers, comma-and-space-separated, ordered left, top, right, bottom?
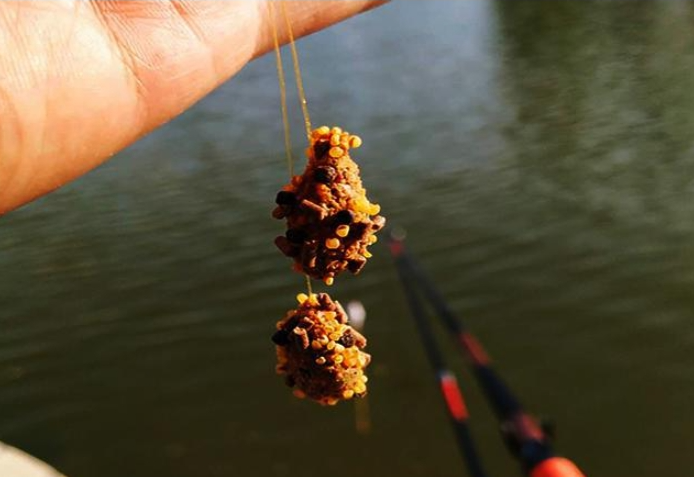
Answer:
272, 126, 385, 283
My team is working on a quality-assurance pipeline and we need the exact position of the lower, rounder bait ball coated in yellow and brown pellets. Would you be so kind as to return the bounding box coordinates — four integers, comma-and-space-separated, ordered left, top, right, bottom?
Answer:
272, 293, 371, 405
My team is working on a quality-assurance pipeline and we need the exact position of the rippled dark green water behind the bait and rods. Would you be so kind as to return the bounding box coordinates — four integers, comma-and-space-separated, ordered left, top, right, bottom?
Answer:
0, 1, 694, 477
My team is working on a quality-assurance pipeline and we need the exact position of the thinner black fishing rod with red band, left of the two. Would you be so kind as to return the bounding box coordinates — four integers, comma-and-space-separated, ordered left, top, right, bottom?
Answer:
396, 244, 487, 477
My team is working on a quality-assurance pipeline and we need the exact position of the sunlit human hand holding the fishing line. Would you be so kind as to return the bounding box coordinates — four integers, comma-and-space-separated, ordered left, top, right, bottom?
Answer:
0, 0, 381, 214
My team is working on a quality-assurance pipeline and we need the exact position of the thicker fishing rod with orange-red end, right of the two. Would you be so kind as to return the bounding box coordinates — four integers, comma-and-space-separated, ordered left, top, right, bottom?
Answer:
389, 231, 584, 477
